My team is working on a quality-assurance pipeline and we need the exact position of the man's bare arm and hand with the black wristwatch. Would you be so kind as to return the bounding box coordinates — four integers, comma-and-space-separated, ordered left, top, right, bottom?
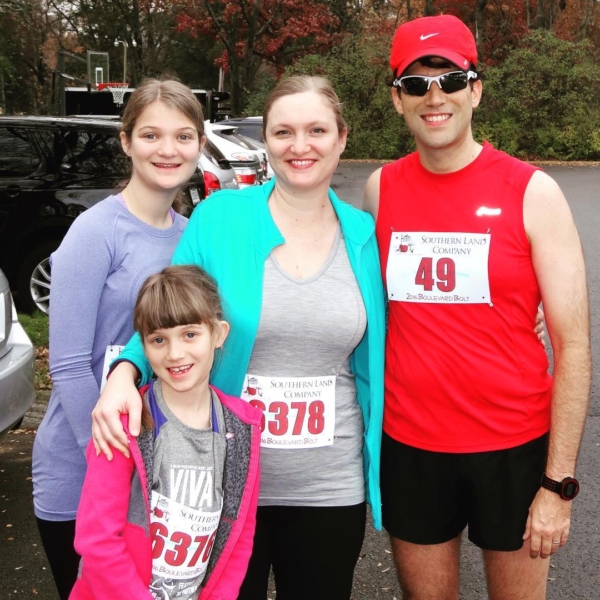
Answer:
523, 172, 591, 558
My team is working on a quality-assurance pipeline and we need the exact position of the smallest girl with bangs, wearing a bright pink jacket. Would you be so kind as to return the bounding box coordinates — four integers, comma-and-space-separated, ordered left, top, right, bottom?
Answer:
70, 266, 262, 600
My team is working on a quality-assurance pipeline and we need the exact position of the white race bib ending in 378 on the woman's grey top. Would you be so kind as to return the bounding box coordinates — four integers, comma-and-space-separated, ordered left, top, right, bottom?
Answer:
241, 374, 336, 448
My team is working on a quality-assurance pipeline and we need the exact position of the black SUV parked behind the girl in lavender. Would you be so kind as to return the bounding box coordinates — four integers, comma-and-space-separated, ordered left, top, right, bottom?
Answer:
0, 117, 204, 312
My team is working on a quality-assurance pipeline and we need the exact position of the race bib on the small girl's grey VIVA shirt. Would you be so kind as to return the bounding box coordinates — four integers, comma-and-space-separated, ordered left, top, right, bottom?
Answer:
150, 484, 221, 600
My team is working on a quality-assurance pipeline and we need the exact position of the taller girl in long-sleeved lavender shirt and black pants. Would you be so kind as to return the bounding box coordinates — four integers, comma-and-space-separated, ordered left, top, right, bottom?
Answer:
33, 80, 205, 599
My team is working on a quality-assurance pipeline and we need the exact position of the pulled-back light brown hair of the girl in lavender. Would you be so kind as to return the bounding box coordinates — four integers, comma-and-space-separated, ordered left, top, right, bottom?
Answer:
119, 79, 204, 212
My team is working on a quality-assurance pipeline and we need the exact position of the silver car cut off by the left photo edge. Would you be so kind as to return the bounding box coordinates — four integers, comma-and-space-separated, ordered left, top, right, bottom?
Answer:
0, 271, 35, 435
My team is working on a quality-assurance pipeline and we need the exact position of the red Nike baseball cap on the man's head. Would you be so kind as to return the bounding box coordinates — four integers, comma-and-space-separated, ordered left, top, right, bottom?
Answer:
390, 15, 477, 76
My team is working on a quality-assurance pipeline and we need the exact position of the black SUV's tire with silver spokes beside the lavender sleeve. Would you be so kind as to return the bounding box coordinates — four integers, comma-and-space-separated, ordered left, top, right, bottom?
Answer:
17, 240, 60, 314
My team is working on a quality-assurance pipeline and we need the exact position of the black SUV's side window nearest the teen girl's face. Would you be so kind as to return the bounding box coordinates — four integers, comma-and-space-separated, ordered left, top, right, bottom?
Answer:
63, 130, 127, 175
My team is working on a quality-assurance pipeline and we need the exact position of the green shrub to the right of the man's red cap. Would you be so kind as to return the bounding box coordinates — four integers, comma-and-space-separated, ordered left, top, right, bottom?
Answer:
474, 30, 600, 160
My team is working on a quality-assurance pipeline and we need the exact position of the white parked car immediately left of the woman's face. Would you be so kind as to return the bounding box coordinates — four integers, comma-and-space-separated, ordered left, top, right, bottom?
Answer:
205, 121, 265, 188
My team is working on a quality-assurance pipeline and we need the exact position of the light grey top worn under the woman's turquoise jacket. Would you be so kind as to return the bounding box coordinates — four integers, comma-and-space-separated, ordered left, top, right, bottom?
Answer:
248, 227, 366, 506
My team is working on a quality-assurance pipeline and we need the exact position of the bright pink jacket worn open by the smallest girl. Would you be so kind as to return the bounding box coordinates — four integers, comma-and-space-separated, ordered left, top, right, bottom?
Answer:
69, 388, 262, 600
